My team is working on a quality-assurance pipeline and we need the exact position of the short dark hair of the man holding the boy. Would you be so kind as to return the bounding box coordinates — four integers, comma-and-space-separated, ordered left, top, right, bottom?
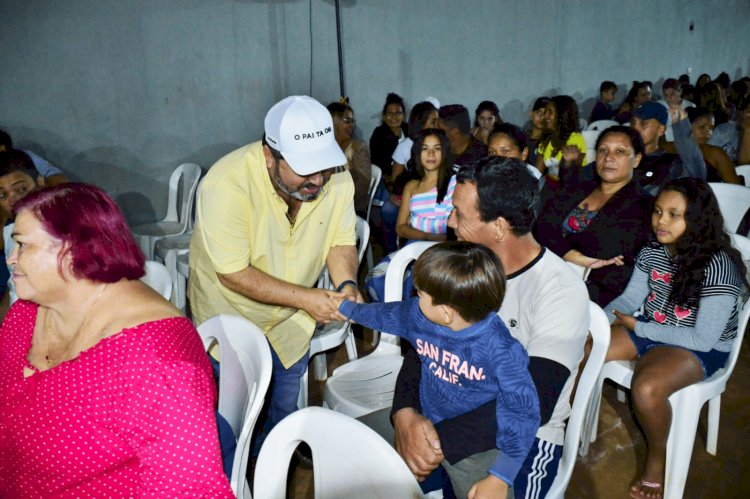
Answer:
456, 156, 540, 236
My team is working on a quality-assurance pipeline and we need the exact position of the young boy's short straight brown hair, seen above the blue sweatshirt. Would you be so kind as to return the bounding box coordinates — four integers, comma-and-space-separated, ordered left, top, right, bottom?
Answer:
412, 241, 505, 323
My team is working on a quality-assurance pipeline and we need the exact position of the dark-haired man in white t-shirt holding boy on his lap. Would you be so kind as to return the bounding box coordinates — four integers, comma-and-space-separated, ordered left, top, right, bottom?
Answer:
363, 157, 589, 497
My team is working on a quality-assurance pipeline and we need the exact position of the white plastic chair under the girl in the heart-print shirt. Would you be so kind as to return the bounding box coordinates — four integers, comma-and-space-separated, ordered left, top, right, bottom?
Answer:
582, 234, 750, 499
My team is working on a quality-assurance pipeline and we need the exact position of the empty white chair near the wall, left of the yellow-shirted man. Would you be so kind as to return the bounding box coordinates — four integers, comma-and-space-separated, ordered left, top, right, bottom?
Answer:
132, 163, 202, 260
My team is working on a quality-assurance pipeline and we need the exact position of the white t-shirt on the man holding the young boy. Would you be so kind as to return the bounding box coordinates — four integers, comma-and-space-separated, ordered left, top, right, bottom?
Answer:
498, 249, 589, 445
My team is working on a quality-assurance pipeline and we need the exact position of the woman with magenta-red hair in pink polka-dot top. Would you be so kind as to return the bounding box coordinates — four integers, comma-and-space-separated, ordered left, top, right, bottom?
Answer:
0, 184, 232, 497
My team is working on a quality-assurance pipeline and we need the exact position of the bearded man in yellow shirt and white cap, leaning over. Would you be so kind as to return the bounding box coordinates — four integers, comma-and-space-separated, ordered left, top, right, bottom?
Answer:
189, 96, 362, 448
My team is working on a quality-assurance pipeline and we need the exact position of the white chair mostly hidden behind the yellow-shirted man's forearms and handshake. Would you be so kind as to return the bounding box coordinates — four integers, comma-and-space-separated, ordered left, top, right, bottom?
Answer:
297, 217, 370, 409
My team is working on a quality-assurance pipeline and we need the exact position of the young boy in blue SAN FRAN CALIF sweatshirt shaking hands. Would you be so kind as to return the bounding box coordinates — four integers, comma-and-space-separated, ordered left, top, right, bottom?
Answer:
339, 241, 540, 497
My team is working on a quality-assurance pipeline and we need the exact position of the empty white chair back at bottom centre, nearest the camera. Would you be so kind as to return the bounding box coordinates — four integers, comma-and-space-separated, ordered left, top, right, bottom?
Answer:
254, 407, 423, 499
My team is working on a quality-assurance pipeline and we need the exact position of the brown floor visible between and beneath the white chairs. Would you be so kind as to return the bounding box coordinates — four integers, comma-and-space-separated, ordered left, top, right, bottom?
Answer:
289, 332, 750, 499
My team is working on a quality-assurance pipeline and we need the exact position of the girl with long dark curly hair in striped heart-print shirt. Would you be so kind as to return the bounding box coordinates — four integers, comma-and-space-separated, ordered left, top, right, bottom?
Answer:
606, 178, 748, 498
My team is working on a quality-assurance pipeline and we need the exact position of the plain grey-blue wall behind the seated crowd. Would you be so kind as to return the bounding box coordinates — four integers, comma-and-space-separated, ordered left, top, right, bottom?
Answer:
0, 0, 750, 223
